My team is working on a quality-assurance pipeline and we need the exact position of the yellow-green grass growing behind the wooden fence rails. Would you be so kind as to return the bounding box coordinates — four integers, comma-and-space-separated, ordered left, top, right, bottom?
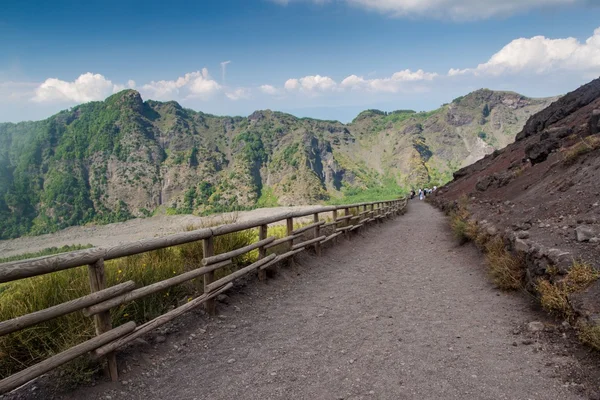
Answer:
0, 217, 312, 383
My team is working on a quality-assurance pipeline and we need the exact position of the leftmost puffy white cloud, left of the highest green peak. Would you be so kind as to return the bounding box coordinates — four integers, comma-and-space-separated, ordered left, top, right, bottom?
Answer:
32, 72, 119, 103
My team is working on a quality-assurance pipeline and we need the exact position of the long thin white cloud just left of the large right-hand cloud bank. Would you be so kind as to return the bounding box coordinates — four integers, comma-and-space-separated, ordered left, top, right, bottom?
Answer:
340, 69, 438, 93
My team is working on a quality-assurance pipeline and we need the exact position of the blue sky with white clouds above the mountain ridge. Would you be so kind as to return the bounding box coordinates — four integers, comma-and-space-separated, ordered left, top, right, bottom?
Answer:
0, 0, 600, 122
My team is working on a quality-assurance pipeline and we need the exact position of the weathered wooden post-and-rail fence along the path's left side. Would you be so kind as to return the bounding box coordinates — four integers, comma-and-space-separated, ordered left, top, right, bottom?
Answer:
0, 199, 406, 395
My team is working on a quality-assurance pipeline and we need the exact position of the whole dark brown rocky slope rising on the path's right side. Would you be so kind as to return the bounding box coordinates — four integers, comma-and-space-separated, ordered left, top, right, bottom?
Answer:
434, 79, 600, 332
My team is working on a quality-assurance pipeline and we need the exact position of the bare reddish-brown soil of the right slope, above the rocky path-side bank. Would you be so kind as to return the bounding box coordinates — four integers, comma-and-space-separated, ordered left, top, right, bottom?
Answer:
435, 79, 600, 268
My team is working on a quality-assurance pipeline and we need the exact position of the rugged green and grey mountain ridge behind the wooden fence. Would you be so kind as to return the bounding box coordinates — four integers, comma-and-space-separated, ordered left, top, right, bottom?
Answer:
0, 89, 554, 238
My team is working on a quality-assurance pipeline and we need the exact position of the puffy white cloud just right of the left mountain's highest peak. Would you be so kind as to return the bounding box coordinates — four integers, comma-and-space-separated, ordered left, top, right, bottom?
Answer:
141, 68, 222, 100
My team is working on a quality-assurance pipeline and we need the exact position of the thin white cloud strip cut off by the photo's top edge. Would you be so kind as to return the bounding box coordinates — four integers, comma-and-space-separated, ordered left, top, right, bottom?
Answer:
271, 0, 590, 20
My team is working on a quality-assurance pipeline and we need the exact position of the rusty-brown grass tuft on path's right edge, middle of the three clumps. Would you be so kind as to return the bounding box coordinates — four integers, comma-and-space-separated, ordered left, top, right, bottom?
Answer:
485, 237, 525, 290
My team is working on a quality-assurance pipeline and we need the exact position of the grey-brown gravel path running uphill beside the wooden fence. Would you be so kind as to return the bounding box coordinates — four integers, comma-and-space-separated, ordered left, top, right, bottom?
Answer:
51, 201, 596, 400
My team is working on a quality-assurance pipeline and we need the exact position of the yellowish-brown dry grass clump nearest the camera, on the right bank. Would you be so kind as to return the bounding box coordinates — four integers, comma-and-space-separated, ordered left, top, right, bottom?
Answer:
536, 262, 600, 319
